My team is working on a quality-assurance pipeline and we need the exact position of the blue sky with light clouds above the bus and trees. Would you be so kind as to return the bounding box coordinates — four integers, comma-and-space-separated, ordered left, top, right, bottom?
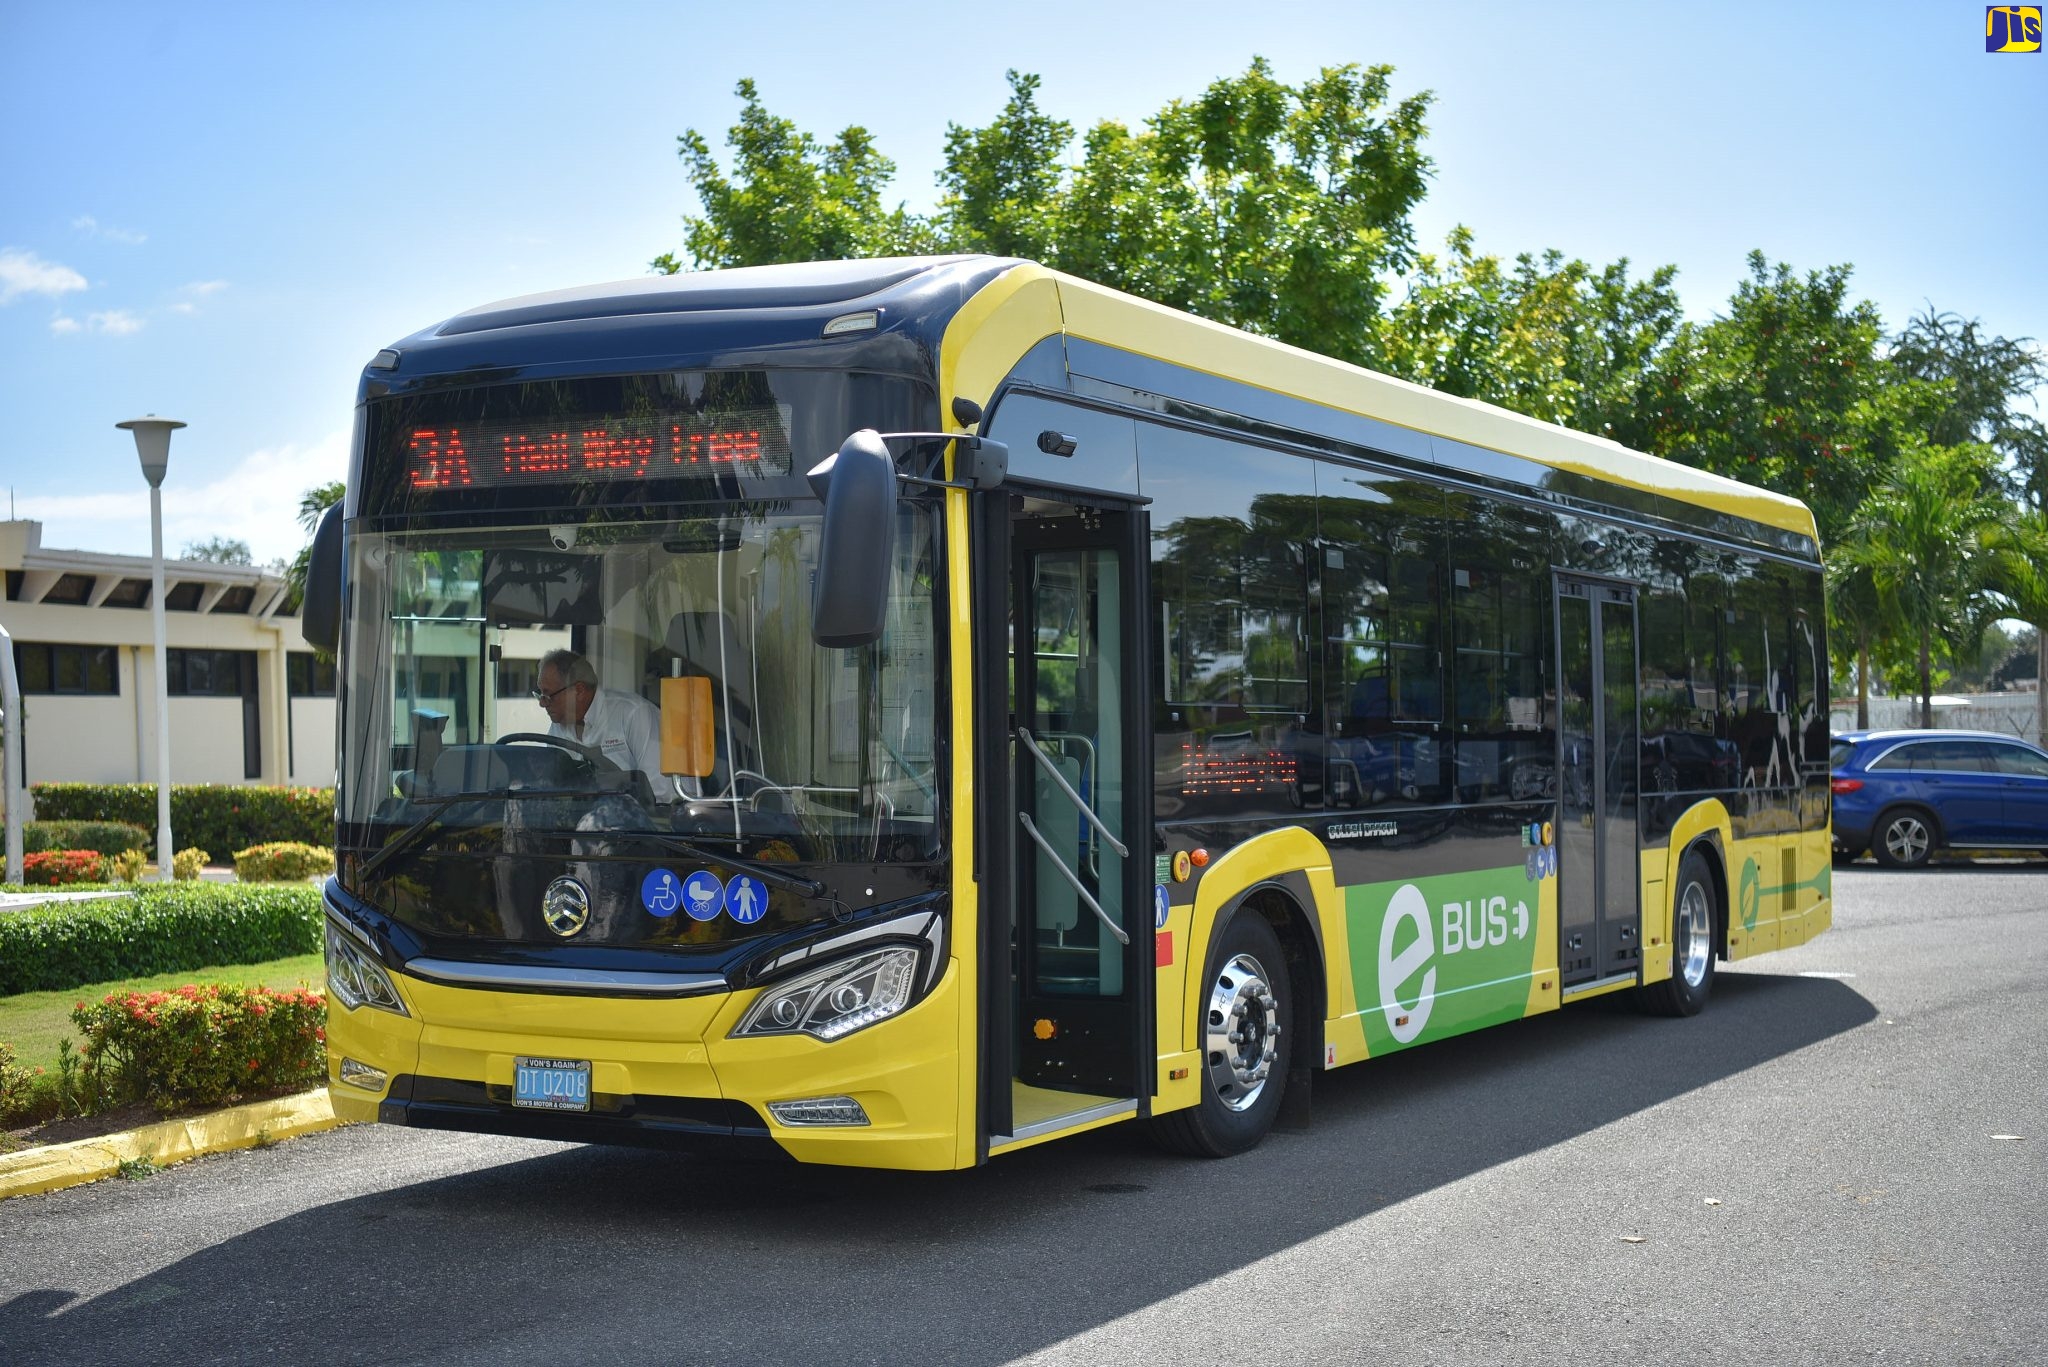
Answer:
0, 0, 2048, 560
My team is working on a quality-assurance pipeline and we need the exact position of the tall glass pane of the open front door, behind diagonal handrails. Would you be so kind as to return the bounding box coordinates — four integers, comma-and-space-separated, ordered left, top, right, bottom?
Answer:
1020, 549, 1124, 996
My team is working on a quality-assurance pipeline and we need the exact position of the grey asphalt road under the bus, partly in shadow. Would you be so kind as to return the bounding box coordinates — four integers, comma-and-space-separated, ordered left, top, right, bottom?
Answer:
0, 865, 2048, 1367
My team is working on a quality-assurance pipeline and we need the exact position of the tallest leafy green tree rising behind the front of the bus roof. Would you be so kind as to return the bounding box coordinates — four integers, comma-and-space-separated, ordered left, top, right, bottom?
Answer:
653, 59, 1430, 361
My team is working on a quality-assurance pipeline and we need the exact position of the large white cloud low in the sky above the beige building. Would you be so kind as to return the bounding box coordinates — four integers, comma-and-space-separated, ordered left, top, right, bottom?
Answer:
16, 432, 348, 564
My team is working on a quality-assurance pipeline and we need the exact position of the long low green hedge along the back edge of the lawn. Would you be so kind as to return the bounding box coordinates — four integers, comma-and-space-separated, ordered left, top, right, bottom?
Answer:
0, 883, 322, 996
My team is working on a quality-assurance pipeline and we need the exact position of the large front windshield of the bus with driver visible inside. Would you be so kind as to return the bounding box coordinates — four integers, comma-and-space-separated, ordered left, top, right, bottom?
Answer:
340, 502, 940, 875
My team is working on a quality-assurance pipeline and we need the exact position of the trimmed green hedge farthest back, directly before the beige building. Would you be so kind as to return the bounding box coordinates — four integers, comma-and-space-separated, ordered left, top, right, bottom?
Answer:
31, 783, 334, 853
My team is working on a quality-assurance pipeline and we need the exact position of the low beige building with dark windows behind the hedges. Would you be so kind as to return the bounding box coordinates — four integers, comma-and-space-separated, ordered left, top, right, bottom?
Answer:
0, 521, 334, 787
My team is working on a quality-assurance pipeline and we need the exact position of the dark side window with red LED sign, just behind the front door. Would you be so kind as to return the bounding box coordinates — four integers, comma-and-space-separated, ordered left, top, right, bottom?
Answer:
1139, 424, 1321, 818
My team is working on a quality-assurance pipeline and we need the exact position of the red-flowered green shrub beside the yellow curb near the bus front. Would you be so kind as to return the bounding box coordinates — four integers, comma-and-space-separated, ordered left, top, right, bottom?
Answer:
72, 984, 328, 1115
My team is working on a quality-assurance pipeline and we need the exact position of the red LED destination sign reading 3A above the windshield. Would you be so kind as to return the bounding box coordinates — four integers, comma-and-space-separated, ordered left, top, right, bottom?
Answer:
406, 408, 791, 490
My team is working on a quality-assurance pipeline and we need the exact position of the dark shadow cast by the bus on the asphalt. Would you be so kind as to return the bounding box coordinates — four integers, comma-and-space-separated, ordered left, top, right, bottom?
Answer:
0, 974, 1876, 1363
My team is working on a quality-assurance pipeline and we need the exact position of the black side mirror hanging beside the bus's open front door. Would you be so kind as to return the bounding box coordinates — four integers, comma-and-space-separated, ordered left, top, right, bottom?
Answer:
807, 428, 897, 650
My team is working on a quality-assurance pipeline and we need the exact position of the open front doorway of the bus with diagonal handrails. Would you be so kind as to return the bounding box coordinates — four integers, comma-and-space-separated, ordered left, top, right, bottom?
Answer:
977, 490, 1157, 1152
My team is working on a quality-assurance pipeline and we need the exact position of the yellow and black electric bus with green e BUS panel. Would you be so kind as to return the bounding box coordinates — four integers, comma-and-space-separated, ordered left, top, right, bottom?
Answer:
305, 256, 1831, 1168
